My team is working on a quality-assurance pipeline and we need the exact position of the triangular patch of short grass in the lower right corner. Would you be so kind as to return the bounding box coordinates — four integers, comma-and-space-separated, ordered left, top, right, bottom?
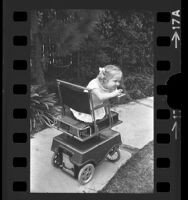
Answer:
99, 141, 154, 193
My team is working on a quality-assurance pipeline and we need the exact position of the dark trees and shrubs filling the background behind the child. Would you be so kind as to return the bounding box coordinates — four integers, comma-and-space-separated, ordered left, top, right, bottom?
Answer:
30, 9, 154, 134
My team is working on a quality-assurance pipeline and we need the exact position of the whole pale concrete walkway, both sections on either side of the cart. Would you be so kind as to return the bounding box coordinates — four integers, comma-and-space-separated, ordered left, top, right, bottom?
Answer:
30, 97, 153, 193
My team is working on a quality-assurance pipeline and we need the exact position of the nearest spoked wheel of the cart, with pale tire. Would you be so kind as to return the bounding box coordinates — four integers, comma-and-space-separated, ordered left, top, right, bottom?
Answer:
78, 163, 95, 185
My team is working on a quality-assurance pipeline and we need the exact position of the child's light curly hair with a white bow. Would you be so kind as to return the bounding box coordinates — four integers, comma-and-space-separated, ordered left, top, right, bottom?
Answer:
97, 65, 123, 85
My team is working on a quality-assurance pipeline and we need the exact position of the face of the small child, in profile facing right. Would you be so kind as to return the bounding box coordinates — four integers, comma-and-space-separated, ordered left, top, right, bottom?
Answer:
104, 72, 122, 91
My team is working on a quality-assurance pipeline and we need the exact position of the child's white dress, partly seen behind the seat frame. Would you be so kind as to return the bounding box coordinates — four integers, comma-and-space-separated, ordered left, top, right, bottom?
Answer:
70, 78, 109, 123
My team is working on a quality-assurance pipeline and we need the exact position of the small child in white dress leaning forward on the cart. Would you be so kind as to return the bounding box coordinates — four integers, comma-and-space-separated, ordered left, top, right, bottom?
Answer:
70, 65, 123, 123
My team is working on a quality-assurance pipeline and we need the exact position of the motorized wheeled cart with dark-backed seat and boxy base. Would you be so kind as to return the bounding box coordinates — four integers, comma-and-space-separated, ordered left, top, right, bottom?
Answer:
51, 80, 122, 184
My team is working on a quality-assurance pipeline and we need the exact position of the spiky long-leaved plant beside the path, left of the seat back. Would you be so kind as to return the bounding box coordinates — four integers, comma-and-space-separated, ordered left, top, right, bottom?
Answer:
30, 85, 62, 133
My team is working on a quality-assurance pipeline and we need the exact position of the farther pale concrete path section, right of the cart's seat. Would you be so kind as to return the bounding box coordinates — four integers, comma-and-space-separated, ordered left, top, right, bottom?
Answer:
113, 97, 154, 149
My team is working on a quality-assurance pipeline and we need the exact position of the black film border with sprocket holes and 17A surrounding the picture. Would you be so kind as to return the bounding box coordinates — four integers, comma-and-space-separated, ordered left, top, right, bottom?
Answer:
2, 0, 181, 200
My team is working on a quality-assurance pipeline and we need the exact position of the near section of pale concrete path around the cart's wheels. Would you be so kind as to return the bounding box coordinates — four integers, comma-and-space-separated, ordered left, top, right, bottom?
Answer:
30, 129, 131, 193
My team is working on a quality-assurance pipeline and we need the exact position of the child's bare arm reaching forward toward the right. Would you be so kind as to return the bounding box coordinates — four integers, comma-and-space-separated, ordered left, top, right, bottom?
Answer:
92, 89, 122, 101
